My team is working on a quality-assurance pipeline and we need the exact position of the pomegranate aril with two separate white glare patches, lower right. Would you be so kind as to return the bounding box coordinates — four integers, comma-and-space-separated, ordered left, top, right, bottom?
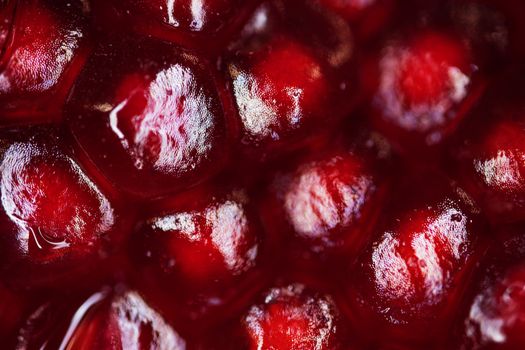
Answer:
341, 174, 485, 345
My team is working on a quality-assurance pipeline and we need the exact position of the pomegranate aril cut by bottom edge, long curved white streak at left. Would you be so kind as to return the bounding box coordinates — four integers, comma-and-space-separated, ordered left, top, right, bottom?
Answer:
17, 289, 187, 350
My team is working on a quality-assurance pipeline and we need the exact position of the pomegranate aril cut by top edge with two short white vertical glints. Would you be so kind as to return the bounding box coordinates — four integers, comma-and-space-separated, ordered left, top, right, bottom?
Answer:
92, 0, 260, 52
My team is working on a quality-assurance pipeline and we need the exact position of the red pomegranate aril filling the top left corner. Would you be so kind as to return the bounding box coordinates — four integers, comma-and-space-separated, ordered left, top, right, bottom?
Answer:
0, 0, 89, 125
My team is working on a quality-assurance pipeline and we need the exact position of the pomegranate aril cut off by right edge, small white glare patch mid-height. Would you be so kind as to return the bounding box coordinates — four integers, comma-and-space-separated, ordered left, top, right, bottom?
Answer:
454, 76, 525, 223
